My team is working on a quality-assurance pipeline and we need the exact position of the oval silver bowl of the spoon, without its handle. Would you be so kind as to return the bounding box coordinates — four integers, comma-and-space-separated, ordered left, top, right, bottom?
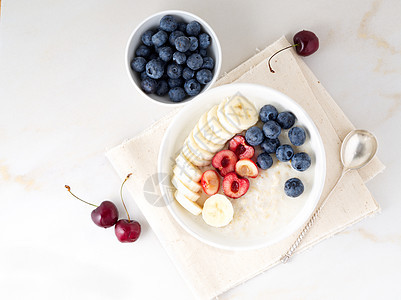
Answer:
341, 129, 377, 170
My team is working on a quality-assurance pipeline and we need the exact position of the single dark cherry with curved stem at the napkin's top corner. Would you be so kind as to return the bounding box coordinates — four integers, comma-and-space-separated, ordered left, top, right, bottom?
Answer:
268, 30, 319, 73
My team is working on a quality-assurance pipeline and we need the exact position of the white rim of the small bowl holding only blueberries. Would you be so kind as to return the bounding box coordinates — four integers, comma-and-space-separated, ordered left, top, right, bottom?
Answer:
124, 10, 222, 107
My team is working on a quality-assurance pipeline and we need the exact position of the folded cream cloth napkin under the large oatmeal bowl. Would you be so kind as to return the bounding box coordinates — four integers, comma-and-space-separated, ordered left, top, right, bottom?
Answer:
106, 37, 384, 299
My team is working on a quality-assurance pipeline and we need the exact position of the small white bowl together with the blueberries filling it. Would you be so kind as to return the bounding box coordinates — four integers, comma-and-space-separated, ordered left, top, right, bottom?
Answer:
125, 10, 221, 105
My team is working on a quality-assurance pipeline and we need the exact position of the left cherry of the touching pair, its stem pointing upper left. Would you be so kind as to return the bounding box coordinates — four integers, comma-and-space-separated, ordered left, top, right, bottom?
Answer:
65, 185, 118, 228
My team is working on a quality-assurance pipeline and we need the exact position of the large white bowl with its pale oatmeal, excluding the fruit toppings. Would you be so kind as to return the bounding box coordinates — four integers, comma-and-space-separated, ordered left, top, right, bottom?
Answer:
158, 83, 326, 250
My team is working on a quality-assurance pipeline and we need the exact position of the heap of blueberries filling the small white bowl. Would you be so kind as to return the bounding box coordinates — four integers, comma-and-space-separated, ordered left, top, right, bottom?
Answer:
131, 15, 214, 102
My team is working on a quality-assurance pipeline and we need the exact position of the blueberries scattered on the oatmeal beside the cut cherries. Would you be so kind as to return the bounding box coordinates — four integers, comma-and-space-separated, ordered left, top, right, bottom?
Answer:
245, 105, 311, 197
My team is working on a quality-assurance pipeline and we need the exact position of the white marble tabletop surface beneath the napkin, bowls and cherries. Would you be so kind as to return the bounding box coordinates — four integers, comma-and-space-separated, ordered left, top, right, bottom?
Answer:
0, 0, 401, 300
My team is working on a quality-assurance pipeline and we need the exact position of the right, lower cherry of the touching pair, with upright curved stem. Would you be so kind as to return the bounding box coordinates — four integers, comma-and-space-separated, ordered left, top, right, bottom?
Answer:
114, 173, 141, 243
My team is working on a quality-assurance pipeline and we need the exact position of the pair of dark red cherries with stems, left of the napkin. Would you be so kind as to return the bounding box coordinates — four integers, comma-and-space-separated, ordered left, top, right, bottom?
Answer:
65, 173, 141, 243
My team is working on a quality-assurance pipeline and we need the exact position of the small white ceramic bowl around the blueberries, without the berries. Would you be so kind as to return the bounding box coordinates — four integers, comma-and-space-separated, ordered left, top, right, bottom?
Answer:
125, 10, 221, 105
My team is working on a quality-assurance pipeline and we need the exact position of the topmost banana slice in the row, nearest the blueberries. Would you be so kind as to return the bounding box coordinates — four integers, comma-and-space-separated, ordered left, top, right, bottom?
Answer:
224, 95, 259, 130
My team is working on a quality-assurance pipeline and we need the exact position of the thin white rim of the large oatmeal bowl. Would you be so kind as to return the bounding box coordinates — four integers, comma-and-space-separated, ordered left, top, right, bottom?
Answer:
157, 83, 327, 251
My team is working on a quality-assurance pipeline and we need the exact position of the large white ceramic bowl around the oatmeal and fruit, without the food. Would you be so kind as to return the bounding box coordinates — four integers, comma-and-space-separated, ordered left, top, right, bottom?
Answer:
158, 83, 326, 250
